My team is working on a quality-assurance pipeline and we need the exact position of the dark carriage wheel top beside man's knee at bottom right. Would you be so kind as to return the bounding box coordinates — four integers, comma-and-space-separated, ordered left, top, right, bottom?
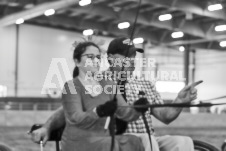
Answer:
193, 140, 219, 151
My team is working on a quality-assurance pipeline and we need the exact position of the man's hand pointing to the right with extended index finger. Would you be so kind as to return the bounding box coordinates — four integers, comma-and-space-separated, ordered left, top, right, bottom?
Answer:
177, 80, 203, 103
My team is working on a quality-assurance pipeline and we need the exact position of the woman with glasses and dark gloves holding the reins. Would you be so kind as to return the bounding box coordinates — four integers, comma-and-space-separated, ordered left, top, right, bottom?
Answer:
62, 42, 147, 151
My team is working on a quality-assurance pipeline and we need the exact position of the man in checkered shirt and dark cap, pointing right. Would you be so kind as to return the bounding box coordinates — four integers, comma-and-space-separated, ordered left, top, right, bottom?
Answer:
32, 38, 201, 151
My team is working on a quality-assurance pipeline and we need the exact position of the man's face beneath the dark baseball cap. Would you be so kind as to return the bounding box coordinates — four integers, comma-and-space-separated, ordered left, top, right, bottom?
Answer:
108, 53, 136, 74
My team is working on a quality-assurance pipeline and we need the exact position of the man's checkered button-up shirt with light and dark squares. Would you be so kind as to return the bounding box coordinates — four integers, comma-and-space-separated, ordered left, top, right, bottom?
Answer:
122, 78, 163, 134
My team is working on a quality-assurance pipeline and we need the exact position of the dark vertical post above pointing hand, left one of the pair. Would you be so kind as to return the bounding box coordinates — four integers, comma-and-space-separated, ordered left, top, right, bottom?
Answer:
184, 46, 190, 85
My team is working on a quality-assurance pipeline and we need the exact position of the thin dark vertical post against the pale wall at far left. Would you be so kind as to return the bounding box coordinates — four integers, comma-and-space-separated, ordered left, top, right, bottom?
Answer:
14, 24, 19, 96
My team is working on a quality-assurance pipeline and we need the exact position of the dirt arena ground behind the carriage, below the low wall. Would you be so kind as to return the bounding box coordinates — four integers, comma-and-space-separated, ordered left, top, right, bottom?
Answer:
0, 127, 226, 151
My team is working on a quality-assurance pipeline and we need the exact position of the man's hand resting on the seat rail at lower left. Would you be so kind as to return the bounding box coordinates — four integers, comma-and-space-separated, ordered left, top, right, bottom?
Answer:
31, 127, 49, 145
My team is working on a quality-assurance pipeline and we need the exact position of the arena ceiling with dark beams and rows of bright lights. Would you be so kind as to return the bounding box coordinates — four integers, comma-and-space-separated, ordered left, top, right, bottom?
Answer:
0, 0, 226, 50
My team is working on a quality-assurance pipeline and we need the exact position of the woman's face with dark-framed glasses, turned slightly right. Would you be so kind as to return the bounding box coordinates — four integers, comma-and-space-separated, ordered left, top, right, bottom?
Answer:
75, 46, 101, 73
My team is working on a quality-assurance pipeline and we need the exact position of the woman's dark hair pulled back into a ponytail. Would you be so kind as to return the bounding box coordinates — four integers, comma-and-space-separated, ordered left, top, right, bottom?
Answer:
73, 41, 100, 78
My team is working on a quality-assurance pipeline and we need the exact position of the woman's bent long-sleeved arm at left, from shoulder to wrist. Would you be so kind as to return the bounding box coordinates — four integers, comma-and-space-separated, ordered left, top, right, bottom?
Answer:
62, 81, 99, 128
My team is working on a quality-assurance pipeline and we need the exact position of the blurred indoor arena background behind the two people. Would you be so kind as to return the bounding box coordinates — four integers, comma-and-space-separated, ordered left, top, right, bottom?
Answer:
0, 0, 226, 151
